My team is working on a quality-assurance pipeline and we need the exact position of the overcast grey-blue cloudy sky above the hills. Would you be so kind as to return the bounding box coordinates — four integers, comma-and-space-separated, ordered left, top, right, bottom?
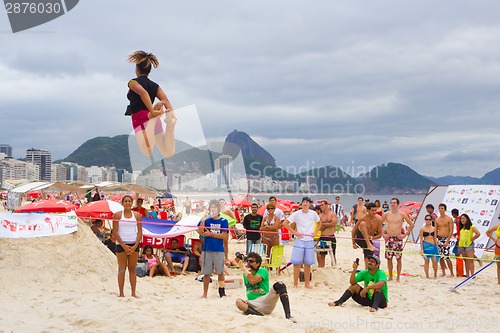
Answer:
0, 0, 500, 177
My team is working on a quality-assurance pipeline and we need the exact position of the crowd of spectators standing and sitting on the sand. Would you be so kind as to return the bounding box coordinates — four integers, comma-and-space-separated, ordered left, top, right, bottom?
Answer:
83, 191, 500, 320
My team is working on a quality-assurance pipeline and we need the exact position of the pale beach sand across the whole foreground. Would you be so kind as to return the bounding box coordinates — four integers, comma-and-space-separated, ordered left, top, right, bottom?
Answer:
0, 223, 500, 333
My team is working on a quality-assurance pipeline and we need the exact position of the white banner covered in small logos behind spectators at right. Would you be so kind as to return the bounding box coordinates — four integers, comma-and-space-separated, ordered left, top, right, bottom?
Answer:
443, 185, 500, 258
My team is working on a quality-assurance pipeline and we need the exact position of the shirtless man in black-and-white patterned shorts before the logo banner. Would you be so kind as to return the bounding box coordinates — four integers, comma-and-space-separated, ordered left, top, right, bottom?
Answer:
434, 203, 455, 277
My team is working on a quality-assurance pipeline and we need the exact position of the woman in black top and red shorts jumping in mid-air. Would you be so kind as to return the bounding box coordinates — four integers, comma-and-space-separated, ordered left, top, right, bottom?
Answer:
125, 51, 177, 158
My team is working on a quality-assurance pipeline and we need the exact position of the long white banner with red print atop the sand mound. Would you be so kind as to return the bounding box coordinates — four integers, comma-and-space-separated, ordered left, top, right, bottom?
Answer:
0, 212, 78, 238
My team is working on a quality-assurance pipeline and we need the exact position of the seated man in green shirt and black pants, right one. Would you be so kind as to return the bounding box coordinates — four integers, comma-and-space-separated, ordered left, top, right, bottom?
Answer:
328, 256, 389, 312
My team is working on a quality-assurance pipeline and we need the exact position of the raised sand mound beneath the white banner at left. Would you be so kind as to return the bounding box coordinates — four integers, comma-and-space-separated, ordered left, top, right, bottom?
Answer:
0, 220, 116, 291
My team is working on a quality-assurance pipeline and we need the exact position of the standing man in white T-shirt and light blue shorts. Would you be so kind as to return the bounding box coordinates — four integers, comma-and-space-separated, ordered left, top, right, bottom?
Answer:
283, 197, 321, 288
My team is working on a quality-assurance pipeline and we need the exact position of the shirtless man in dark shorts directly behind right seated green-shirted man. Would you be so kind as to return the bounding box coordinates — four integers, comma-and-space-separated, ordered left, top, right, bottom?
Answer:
352, 198, 382, 267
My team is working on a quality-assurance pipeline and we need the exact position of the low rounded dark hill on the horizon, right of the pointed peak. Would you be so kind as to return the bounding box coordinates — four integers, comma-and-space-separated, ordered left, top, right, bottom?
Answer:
362, 163, 432, 193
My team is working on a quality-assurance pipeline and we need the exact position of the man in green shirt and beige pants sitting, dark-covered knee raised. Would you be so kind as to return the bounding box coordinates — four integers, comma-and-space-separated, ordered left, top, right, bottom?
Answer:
236, 252, 296, 323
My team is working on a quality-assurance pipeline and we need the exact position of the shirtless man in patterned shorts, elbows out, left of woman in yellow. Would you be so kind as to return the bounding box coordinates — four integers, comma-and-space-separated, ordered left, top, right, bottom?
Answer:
382, 198, 415, 282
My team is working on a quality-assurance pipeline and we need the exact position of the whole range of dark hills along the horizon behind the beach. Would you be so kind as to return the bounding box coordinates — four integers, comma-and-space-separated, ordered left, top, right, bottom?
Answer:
57, 130, 500, 193
